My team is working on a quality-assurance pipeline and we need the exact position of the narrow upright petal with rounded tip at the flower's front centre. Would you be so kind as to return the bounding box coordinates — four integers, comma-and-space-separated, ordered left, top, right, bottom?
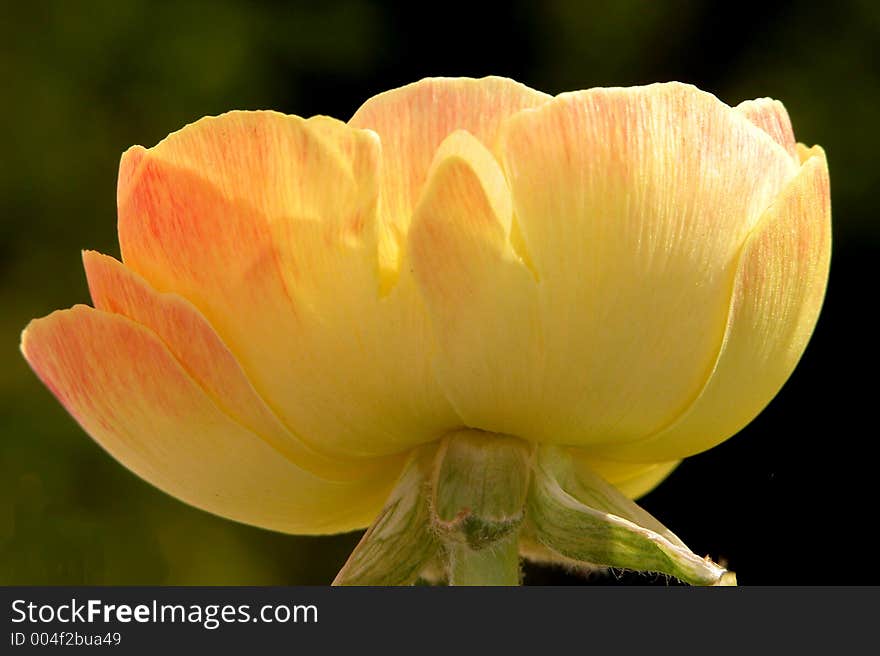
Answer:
406, 131, 543, 436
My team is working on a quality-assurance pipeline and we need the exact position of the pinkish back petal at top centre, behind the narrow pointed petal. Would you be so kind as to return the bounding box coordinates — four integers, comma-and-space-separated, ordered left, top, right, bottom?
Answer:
349, 77, 551, 284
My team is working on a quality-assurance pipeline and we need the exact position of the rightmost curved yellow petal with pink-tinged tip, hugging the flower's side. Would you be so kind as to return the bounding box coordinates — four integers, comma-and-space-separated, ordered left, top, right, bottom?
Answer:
607, 147, 831, 462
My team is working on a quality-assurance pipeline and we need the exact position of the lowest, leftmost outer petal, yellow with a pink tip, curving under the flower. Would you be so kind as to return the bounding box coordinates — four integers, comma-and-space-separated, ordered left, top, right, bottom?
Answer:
22, 306, 398, 533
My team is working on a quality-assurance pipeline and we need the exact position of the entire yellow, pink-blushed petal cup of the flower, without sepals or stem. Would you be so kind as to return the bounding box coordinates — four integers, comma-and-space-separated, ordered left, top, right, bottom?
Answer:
22, 78, 830, 584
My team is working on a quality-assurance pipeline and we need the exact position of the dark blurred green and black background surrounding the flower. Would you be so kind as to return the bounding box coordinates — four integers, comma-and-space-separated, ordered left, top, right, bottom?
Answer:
0, 0, 880, 584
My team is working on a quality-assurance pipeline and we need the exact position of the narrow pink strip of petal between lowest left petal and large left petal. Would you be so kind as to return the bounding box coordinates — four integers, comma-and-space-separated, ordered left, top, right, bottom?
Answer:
83, 251, 381, 480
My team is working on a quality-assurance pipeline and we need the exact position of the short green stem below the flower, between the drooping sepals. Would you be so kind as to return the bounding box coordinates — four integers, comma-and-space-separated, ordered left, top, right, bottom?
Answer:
447, 531, 520, 585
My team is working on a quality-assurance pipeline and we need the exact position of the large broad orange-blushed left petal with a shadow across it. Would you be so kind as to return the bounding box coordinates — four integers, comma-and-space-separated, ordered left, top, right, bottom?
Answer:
119, 112, 459, 457
